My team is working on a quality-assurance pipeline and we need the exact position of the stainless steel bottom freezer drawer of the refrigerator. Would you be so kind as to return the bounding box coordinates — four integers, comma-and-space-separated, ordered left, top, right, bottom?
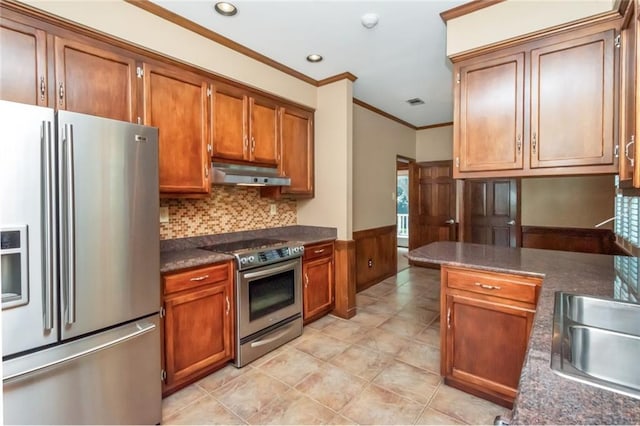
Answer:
3, 315, 162, 424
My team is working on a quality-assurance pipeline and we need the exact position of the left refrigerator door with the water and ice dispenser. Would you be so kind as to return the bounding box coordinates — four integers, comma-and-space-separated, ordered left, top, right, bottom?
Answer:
0, 101, 58, 357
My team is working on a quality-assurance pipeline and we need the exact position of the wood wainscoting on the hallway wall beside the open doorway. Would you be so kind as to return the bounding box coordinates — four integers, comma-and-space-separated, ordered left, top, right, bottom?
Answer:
353, 225, 398, 291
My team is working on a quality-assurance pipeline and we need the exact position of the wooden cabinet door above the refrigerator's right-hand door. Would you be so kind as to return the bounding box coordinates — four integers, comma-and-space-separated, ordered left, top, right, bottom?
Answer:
54, 37, 137, 122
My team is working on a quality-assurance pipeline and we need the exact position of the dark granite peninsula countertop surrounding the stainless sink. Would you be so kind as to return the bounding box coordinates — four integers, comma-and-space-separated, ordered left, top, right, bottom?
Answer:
408, 242, 640, 424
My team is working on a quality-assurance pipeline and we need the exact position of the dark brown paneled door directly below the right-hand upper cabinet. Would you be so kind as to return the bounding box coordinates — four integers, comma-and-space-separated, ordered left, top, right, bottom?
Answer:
463, 178, 520, 247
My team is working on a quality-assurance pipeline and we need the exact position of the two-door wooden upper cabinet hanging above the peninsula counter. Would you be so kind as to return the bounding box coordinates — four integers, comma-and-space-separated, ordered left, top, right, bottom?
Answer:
454, 20, 620, 178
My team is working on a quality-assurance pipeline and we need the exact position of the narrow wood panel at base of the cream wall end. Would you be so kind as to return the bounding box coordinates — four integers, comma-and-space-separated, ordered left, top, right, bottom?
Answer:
332, 240, 356, 319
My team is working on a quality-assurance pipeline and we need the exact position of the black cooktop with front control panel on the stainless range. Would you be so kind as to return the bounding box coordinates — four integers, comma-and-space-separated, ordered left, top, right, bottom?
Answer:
200, 238, 304, 271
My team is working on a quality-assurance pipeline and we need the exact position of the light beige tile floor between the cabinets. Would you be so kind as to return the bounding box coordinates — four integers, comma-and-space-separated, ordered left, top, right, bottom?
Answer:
162, 267, 510, 425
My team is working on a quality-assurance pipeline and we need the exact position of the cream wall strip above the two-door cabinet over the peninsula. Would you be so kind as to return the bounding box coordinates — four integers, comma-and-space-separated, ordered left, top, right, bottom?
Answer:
447, 0, 616, 56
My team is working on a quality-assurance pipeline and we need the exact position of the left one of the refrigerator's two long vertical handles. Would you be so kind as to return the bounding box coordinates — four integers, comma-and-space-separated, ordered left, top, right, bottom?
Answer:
41, 121, 57, 330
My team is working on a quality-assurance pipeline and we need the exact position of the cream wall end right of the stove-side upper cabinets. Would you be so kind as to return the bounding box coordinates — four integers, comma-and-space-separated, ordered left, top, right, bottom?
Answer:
298, 80, 353, 240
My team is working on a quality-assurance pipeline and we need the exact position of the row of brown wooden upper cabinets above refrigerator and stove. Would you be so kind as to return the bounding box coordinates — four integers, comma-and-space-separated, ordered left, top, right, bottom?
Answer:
0, 2, 314, 197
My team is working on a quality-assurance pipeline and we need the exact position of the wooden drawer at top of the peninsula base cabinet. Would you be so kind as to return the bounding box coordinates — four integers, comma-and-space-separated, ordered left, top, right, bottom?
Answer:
447, 268, 541, 305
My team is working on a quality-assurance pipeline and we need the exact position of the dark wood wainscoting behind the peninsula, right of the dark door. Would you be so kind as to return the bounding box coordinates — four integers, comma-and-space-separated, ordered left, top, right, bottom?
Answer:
522, 226, 620, 254
